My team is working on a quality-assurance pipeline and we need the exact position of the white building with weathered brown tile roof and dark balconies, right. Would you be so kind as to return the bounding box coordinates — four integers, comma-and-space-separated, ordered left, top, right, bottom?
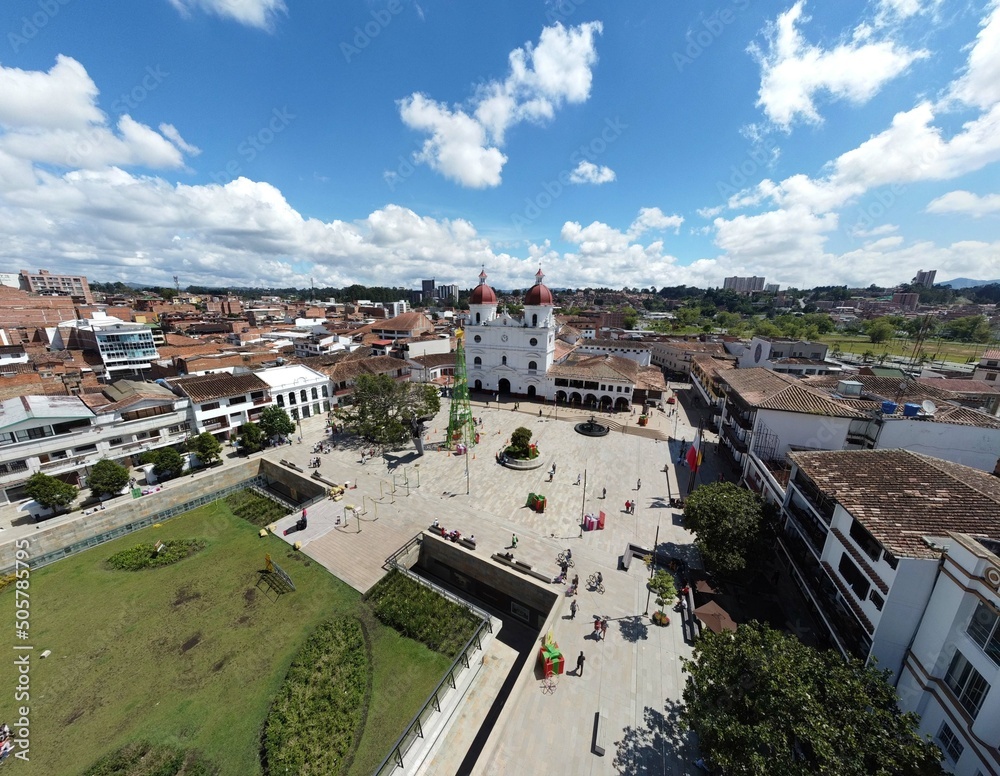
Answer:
779, 450, 1000, 692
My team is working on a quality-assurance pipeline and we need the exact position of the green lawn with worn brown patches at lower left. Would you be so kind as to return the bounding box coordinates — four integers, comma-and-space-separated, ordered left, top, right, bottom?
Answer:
0, 502, 450, 776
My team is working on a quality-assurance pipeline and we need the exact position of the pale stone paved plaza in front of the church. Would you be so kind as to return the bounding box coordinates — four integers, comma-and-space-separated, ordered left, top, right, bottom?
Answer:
0, 391, 718, 776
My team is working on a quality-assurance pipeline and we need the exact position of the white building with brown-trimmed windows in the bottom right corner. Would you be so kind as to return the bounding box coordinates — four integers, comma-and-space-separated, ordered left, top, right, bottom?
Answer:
897, 532, 1000, 776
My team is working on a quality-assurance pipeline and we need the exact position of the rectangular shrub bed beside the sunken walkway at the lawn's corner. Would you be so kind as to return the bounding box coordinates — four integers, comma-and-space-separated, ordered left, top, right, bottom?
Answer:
366, 569, 479, 657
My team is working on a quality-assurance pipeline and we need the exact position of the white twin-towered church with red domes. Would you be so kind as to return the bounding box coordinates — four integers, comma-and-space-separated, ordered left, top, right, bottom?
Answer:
465, 269, 556, 398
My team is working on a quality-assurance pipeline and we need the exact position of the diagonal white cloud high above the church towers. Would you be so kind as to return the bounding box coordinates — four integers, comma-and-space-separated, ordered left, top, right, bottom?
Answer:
399, 22, 606, 188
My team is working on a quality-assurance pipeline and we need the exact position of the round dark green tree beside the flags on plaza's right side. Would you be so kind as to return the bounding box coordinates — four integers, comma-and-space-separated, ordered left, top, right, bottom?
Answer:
684, 482, 772, 574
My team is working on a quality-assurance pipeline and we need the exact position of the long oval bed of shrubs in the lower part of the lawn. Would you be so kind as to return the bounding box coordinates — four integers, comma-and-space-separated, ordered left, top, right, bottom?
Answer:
262, 617, 371, 776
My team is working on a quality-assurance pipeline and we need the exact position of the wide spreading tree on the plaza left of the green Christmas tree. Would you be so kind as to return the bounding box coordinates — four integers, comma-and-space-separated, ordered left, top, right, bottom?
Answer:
337, 375, 441, 445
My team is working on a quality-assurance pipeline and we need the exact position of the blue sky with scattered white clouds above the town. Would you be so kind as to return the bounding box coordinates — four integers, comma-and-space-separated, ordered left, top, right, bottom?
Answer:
0, 0, 1000, 288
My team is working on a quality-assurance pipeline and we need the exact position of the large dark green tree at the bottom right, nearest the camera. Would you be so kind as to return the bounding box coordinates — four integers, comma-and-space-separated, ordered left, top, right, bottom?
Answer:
682, 622, 943, 776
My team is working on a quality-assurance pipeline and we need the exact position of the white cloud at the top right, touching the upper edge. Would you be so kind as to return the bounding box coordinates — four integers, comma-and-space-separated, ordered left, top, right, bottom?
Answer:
749, 0, 929, 129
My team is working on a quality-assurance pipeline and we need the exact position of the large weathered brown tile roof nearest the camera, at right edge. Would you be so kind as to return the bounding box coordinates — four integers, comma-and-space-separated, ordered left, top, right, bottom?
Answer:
788, 450, 1000, 558
